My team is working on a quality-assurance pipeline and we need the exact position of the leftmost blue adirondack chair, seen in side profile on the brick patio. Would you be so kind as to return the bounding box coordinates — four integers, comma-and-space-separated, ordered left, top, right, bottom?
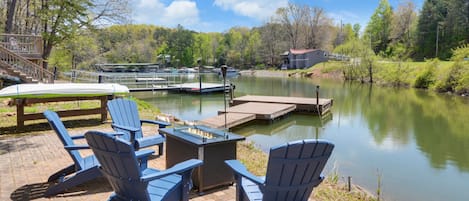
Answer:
44, 110, 154, 196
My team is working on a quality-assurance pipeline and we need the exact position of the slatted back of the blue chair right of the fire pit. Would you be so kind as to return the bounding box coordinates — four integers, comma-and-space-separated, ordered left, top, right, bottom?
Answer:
261, 140, 334, 201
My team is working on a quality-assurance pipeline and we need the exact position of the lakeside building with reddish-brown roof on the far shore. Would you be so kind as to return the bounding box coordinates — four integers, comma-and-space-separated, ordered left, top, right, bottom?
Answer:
280, 49, 329, 69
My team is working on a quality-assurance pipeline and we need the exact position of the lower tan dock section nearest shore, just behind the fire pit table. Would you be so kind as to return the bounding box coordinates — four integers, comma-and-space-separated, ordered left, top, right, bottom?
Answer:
198, 113, 256, 129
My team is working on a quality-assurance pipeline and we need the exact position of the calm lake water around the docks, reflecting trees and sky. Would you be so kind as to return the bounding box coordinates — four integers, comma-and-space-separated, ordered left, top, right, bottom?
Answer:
132, 76, 469, 201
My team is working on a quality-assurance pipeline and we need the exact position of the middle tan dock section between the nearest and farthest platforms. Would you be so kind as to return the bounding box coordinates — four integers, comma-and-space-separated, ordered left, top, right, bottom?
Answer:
218, 102, 296, 120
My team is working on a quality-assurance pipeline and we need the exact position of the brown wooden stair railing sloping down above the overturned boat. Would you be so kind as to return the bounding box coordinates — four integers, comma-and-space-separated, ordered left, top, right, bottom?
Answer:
0, 45, 54, 83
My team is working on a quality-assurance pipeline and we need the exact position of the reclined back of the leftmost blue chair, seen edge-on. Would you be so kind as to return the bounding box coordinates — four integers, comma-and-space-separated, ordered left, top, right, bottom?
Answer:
44, 110, 84, 169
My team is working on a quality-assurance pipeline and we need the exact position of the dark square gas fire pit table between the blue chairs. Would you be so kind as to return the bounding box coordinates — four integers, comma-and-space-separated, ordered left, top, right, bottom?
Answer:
160, 126, 245, 194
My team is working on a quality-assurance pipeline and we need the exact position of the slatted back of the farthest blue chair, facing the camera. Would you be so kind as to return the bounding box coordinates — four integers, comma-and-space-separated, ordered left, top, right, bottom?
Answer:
107, 98, 143, 140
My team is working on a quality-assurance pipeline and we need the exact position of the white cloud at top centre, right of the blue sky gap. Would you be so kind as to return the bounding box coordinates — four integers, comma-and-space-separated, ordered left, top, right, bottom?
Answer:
213, 0, 288, 20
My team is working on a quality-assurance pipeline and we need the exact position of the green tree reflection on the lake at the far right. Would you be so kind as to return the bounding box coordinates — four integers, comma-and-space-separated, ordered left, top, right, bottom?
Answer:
340, 82, 469, 171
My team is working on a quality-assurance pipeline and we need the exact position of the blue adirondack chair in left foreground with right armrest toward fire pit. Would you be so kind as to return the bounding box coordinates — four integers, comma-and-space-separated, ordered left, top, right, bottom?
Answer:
85, 131, 202, 201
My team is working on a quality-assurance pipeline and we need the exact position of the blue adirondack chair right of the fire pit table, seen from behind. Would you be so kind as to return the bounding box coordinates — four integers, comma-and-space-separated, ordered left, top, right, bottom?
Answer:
225, 140, 334, 201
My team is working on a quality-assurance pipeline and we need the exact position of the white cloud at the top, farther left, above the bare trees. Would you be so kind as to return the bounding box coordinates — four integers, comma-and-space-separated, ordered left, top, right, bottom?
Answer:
133, 0, 200, 27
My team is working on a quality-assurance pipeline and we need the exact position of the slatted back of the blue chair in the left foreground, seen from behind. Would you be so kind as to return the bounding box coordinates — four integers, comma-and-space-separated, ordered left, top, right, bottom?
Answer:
85, 131, 150, 201
